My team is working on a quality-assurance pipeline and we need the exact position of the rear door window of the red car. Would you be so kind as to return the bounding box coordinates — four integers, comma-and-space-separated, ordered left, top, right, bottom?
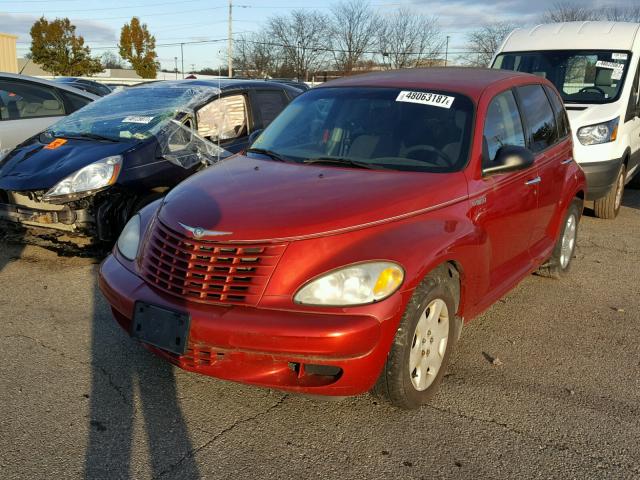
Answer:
517, 85, 558, 152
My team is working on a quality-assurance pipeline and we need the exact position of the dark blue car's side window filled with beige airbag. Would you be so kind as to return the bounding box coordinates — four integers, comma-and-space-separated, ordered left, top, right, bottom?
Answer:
197, 95, 247, 141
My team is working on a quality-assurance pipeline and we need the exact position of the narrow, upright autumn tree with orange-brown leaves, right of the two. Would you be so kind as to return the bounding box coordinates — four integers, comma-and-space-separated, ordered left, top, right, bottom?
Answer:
119, 17, 158, 78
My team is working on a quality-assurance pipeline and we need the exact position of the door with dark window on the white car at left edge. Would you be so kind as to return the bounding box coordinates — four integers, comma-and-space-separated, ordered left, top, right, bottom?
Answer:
0, 78, 66, 150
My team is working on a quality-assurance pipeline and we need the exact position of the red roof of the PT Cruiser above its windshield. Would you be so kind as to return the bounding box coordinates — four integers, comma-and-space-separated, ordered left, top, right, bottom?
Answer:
316, 67, 543, 100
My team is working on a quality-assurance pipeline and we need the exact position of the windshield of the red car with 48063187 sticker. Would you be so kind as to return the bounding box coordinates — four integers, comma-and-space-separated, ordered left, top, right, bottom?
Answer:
252, 87, 473, 172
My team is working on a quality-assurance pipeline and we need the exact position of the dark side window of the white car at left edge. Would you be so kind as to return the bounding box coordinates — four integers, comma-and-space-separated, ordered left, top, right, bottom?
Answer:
0, 80, 65, 120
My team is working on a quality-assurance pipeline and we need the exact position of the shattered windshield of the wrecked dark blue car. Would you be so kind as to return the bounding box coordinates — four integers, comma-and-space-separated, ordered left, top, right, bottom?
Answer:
49, 86, 218, 141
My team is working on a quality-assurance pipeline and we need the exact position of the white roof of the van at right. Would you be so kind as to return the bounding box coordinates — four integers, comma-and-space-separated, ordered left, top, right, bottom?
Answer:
500, 21, 640, 52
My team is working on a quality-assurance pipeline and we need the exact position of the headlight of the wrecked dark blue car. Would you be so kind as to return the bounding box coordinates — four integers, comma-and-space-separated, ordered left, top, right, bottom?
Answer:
44, 155, 122, 200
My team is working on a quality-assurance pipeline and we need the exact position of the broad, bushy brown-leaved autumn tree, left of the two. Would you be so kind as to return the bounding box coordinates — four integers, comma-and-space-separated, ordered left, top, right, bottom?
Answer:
31, 17, 102, 77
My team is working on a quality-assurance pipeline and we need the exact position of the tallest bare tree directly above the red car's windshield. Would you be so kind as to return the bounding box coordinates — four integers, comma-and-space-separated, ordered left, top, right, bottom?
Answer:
331, 0, 381, 74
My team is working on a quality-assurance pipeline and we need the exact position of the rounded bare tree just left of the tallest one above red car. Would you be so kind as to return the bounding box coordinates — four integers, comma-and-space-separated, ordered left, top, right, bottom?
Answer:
267, 10, 330, 80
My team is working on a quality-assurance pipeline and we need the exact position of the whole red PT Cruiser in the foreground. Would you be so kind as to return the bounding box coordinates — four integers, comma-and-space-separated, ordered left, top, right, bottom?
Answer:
100, 68, 585, 408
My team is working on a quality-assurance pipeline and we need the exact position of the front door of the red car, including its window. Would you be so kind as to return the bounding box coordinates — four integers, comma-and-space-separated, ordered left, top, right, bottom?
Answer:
480, 90, 538, 292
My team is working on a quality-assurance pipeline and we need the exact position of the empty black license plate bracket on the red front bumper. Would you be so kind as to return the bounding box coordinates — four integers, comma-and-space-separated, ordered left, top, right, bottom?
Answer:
131, 302, 191, 355
